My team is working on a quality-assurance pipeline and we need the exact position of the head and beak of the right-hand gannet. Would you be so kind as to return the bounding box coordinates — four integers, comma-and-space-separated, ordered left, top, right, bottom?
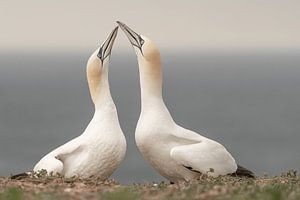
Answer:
117, 21, 160, 63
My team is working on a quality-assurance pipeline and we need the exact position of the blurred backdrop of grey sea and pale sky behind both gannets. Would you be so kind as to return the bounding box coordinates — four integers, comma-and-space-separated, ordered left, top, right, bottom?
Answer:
0, 0, 300, 184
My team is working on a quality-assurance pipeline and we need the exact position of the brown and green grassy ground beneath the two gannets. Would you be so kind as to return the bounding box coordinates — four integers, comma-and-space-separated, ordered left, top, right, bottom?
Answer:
0, 171, 300, 200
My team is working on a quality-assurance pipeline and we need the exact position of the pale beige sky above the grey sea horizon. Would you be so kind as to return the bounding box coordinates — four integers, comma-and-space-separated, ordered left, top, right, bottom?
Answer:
0, 0, 300, 51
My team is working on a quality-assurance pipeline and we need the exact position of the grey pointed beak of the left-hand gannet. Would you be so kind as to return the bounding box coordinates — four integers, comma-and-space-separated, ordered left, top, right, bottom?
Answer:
97, 26, 118, 62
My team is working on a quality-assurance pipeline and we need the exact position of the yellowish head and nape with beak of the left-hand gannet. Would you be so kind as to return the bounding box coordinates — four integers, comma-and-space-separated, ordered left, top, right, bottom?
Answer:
87, 27, 118, 103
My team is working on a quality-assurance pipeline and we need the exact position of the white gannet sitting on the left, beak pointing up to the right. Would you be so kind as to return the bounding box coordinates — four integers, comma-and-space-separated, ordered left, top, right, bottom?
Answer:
33, 27, 126, 179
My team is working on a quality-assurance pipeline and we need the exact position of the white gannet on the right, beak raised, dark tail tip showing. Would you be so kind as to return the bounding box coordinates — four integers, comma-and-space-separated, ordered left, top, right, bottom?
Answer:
117, 22, 254, 182
